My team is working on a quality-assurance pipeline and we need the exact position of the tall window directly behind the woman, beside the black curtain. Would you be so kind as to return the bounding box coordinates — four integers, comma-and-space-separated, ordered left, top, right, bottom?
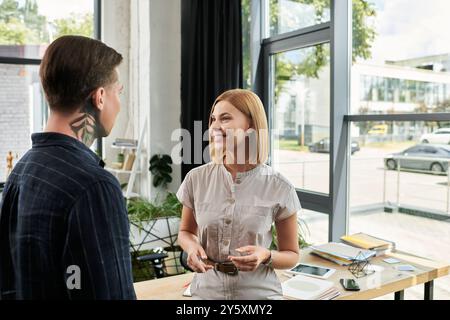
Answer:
250, 0, 332, 244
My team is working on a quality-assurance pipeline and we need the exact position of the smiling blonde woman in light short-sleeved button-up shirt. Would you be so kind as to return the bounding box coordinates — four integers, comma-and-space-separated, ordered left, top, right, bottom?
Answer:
177, 89, 301, 300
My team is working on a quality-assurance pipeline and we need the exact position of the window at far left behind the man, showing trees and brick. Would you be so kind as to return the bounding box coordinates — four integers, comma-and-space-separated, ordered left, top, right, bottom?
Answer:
0, 0, 100, 182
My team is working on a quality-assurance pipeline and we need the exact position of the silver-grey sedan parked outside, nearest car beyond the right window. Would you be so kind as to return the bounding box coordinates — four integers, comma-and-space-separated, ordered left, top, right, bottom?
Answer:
384, 144, 450, 174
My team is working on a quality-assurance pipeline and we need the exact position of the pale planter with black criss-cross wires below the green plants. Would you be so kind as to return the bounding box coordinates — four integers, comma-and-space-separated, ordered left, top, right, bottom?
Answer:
130, 217, 180, 251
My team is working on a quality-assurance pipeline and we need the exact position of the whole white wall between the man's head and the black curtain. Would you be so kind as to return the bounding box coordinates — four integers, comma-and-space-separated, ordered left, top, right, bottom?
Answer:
103, 0, 181, 198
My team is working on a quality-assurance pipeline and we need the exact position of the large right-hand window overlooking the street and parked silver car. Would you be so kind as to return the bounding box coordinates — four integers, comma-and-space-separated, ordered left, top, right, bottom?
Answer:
346, 0, 450, 299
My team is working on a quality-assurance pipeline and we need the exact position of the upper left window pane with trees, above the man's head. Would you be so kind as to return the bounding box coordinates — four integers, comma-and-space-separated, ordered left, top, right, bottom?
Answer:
0, 0, 94, 59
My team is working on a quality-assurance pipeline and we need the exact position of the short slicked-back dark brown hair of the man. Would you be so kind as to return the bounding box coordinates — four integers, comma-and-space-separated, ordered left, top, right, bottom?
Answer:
39, 36, 123, 113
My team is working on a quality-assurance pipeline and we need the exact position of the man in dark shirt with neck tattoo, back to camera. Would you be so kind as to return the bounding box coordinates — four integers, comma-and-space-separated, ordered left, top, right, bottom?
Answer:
0, 36, 136, 299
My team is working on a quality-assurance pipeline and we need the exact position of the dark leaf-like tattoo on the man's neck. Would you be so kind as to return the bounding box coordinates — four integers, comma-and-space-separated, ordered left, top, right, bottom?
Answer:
70, 97, 105, 147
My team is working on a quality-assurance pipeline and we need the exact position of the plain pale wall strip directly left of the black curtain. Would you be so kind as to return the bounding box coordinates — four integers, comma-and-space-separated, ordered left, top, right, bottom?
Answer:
150, 0, 181, 198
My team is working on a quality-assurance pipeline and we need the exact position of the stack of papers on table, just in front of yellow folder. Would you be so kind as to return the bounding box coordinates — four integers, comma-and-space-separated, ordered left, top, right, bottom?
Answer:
311, 242, 376, 266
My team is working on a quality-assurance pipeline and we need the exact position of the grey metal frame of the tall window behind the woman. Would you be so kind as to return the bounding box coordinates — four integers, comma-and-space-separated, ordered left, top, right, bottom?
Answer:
251, 0, 352, 241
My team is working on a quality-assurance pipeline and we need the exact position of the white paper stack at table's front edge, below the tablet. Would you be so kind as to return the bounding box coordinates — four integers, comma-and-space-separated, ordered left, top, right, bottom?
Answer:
281, 275, 340, 300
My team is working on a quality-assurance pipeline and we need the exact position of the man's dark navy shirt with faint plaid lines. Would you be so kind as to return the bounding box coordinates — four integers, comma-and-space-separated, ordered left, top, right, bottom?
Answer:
0, 133, 135, 299
